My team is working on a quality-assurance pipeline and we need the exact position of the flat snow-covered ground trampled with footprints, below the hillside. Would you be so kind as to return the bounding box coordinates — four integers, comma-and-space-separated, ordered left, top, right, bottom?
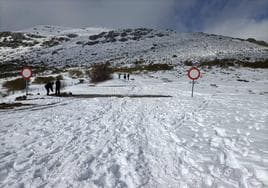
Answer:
0, 69, 268, 188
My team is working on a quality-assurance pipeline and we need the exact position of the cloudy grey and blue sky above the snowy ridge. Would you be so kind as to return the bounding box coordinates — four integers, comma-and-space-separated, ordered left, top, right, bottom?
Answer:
0, 0, 268, 41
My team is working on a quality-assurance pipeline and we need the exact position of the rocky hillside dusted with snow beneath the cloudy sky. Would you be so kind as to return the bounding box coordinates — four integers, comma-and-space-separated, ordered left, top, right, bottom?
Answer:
0, 26, 268, 66
